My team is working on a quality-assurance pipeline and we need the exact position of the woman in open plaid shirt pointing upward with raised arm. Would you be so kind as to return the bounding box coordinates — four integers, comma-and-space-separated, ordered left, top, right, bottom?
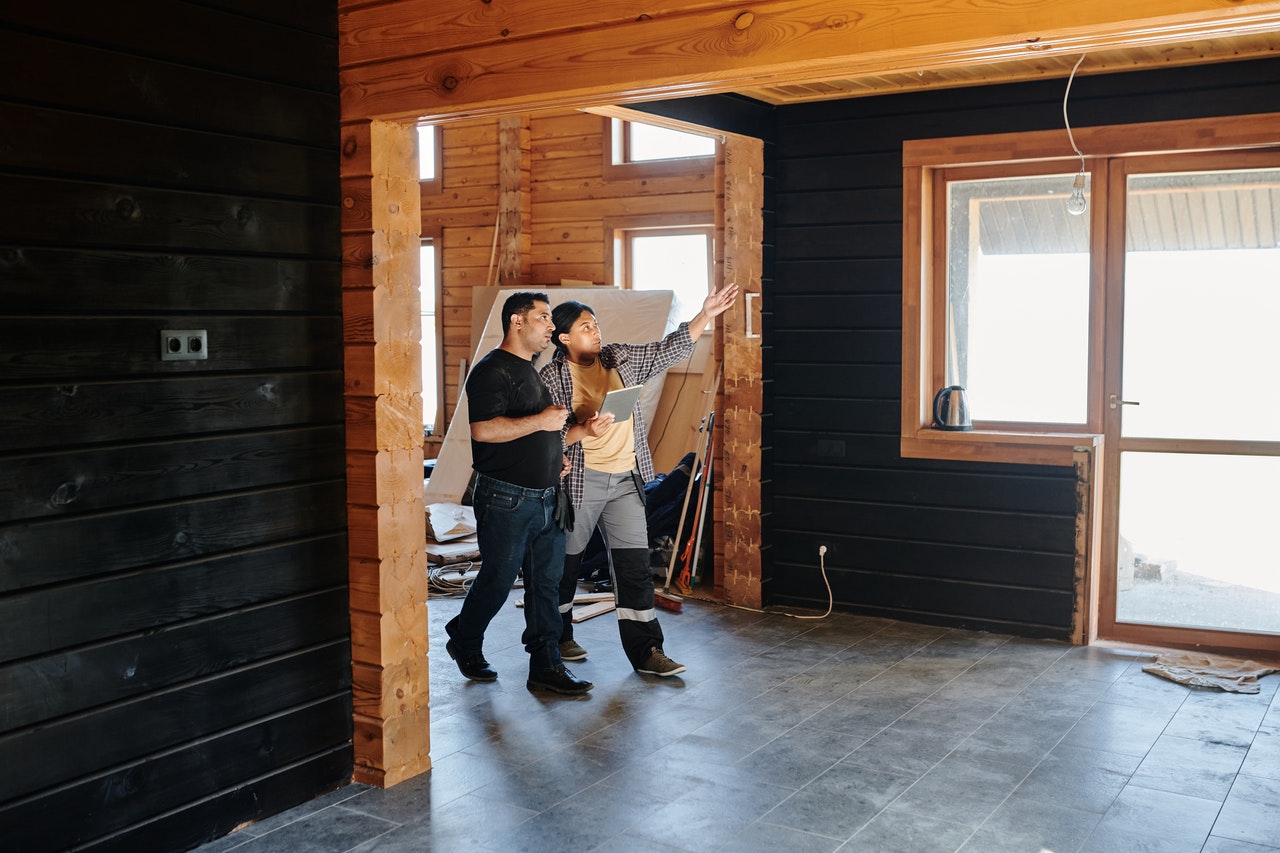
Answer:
539, 284, 737, 676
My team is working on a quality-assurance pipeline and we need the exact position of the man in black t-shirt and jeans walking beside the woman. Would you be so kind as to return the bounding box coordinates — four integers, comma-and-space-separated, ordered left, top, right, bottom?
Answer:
444, 292, 594, 694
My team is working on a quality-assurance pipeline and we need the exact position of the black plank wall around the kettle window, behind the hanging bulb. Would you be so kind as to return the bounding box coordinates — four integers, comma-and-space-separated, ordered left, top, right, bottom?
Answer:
764, 59, 1280, 638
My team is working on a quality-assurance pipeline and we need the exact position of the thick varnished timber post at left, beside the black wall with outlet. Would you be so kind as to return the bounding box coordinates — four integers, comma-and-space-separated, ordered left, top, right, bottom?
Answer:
342, 122, 430, 786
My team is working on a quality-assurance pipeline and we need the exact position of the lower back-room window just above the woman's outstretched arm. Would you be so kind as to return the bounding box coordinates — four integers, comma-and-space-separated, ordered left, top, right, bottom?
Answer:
613, 225, 714, 323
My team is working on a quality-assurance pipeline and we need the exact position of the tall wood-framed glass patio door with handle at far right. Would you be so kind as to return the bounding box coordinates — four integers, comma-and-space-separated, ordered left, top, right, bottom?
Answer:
1100, 154, 1280, 651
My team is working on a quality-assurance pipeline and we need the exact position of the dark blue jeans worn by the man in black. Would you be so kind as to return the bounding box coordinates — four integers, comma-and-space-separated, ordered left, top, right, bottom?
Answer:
445, 474, 564, 672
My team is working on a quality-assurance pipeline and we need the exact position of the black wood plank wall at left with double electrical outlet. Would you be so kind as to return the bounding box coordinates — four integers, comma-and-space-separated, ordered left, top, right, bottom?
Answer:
0, 0, 352, 852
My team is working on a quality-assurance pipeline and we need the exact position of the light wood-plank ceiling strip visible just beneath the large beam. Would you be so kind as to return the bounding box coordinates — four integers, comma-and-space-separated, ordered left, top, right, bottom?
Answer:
737, 32, 1280, 106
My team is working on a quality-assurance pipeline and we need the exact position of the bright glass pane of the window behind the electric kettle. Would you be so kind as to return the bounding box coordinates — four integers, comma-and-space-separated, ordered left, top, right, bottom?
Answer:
938, 170, 1089, 429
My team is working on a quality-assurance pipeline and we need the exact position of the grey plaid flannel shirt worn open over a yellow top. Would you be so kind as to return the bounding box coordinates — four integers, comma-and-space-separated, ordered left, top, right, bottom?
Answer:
539, 323, 694, 510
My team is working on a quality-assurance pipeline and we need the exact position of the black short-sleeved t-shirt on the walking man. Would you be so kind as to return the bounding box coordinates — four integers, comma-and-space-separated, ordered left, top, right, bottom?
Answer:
467, 350, 564, 489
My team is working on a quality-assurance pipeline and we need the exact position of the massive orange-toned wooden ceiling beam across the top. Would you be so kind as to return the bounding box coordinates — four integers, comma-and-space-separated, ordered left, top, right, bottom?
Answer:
339, 0, 1280, 120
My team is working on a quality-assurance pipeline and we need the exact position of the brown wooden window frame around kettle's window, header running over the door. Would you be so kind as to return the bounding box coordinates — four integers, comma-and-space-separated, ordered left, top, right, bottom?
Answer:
900, 113, 1280, 466
